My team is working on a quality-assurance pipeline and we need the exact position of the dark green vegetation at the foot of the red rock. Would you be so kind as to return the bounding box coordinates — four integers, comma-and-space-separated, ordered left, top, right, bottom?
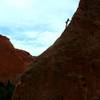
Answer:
0, 80, 15, 100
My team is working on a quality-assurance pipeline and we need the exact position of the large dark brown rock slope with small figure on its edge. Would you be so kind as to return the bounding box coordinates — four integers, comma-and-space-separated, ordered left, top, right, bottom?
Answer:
13, 0, 100, 100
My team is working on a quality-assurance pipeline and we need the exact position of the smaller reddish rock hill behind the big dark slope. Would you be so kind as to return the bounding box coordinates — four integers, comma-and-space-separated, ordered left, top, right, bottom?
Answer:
0, 35, 33, 82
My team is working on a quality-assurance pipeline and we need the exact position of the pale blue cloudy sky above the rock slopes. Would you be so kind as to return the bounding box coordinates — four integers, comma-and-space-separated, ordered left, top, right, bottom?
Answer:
0, 0, 79, 56
